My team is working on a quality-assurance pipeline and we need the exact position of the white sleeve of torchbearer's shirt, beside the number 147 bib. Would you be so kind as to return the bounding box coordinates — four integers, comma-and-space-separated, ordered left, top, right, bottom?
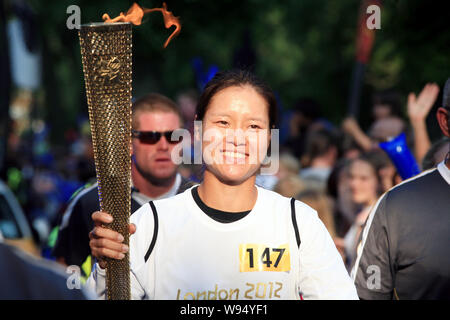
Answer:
295, 201, 358, 300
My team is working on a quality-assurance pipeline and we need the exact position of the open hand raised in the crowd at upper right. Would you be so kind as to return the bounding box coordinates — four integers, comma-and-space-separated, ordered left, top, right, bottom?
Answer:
408, 83, 439, 125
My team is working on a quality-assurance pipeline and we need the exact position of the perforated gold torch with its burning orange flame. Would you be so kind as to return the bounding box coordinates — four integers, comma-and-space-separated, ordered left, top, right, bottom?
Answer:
78, 3, 181, 300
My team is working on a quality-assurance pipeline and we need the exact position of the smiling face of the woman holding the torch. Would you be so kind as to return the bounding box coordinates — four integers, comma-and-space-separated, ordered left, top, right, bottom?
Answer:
202, 86, 270, 184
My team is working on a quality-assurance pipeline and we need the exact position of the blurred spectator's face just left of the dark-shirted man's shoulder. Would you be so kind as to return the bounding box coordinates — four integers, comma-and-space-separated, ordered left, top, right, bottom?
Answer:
349, 160, 378, 205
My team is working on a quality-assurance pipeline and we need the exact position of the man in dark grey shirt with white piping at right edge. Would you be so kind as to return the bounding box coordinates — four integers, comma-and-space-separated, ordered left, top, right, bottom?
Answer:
352, 79, 450, 299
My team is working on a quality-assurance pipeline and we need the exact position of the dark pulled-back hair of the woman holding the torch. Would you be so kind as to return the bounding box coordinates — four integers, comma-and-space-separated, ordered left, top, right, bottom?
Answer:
196, 69, 278, 128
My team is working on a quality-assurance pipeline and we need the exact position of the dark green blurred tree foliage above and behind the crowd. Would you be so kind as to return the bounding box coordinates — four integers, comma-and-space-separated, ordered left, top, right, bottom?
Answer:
23, 0, 450, 139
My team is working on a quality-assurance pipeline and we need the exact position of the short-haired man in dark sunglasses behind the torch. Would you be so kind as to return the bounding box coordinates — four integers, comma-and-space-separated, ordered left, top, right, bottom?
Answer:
53, 93, 193, 276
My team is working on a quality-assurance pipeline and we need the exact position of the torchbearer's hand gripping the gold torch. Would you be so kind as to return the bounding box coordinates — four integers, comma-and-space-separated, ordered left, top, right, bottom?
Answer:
89, 211, 136, 269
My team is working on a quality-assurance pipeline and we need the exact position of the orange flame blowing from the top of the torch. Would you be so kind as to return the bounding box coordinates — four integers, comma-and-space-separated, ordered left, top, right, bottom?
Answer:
102, 2, 181, 48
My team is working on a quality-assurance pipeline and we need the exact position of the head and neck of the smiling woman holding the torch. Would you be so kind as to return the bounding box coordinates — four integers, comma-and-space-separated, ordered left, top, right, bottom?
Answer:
196, 71, 276, 212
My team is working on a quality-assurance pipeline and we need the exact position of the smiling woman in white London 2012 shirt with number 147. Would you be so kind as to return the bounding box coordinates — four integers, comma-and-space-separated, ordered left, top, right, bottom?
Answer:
90, 71, 357, 299
